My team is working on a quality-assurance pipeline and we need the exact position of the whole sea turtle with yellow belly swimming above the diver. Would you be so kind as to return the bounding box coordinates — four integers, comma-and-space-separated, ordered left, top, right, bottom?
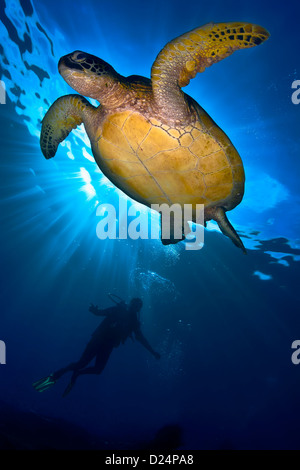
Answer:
41, 23, 269, 251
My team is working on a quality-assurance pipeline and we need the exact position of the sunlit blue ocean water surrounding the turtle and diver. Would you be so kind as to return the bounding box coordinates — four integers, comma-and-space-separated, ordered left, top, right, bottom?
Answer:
0, 0, 300, 449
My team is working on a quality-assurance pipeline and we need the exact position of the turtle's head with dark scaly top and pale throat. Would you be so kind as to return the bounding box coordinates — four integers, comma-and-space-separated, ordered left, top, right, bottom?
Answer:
58, 51, 121, 101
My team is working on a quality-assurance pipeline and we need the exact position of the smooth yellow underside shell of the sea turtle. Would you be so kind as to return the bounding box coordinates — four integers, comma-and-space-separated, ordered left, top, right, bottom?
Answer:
93, 111, 244, 206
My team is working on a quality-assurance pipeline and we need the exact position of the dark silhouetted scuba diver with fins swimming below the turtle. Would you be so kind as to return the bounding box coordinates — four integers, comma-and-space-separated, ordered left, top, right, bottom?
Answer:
33, 295, 160, 397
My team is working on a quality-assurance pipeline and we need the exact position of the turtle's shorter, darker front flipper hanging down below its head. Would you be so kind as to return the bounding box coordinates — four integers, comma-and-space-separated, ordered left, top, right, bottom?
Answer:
40, 95, 95, 159
